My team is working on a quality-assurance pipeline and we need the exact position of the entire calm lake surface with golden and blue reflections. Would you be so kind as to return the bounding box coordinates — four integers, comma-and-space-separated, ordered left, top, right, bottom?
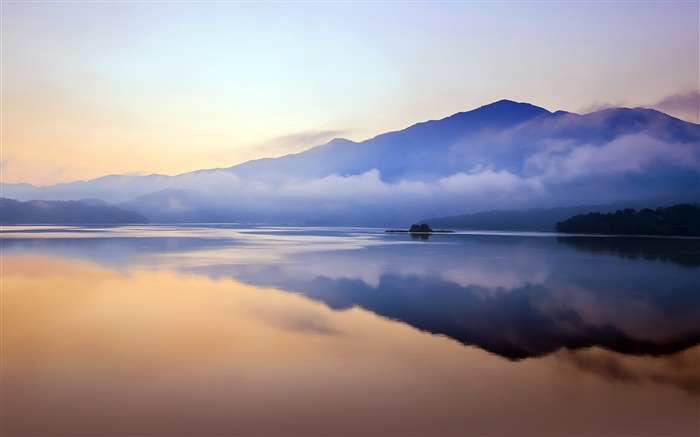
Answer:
0, 225, 700, 436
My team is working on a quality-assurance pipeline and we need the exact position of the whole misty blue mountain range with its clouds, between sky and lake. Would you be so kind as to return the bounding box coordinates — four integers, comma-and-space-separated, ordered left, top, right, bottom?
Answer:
3, 100, 700, 226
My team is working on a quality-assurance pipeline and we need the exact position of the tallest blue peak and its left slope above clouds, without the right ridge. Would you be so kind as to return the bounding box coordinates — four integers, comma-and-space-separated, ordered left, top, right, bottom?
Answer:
227, 100, 551, 183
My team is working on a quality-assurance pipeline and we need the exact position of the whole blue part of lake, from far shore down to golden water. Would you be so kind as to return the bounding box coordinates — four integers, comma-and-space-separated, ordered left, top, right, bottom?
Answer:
5, 227, 700, 360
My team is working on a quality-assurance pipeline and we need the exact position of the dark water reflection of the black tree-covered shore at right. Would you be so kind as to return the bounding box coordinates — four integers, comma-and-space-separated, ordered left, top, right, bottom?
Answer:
557, 236, 700, 266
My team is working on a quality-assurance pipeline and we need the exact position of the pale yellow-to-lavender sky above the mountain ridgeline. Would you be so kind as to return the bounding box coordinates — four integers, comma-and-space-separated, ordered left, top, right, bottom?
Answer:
1, 1, 700, 185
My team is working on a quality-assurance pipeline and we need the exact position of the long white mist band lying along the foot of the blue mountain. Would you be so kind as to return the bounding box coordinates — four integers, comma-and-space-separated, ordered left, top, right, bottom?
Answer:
133, 168, 547, 225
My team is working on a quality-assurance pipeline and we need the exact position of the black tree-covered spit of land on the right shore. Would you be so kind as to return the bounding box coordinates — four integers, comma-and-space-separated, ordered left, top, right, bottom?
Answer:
556, 203, 700, 236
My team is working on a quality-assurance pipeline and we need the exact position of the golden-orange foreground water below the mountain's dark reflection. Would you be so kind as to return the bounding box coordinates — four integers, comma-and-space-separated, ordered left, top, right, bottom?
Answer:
2, 256, 700, 436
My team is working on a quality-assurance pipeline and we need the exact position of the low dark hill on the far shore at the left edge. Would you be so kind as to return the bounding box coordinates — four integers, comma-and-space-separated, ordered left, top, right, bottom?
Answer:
0, 197, 148, 225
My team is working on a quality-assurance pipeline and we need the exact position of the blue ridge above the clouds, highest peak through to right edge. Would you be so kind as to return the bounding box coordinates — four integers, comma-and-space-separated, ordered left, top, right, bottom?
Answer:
226, 100, 698, 182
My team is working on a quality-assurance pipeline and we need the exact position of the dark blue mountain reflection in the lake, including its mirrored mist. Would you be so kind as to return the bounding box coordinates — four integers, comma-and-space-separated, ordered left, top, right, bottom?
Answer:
178, 238, 700, 359
